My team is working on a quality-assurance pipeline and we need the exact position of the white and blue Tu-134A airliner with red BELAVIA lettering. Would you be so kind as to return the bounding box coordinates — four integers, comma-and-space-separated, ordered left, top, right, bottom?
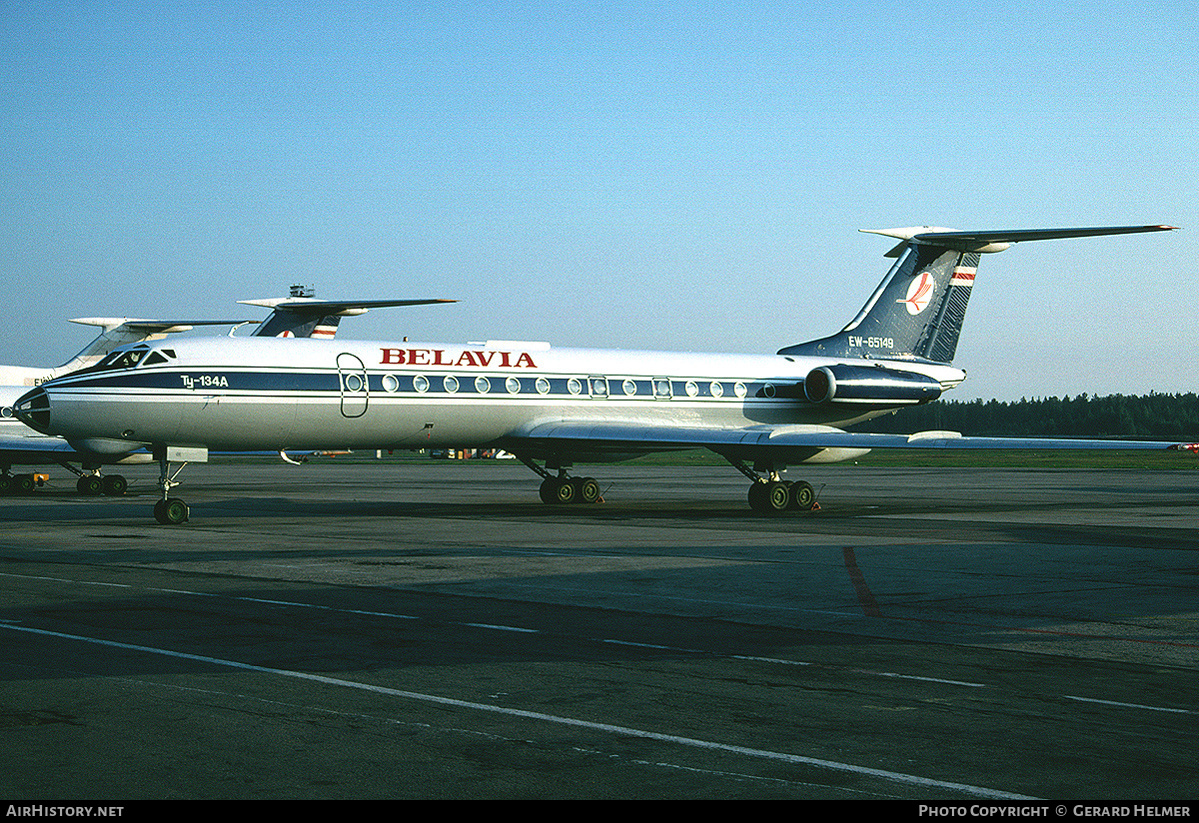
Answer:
14, 226, 1182, 524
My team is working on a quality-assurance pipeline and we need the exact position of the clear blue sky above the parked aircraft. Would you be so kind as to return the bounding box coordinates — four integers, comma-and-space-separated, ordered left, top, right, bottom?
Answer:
0, 0, 1199, 400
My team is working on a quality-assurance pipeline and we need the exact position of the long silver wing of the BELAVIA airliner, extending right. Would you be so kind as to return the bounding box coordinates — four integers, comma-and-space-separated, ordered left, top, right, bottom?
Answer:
505, 422, 1195, 462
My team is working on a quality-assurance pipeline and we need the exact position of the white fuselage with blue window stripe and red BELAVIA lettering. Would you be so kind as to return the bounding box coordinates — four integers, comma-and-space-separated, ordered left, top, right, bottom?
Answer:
25, 338, 965, 451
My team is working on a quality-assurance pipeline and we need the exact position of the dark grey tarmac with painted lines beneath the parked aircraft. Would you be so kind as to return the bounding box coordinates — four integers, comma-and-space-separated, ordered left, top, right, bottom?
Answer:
0, 458, 1199, 805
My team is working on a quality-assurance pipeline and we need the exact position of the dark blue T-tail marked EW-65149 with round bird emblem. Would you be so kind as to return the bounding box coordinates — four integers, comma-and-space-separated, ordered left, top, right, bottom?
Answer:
778, 226, 1174, 364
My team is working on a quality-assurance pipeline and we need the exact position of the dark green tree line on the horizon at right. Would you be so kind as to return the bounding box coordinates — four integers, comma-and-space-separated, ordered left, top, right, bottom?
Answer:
854, 392, 1199, 440
